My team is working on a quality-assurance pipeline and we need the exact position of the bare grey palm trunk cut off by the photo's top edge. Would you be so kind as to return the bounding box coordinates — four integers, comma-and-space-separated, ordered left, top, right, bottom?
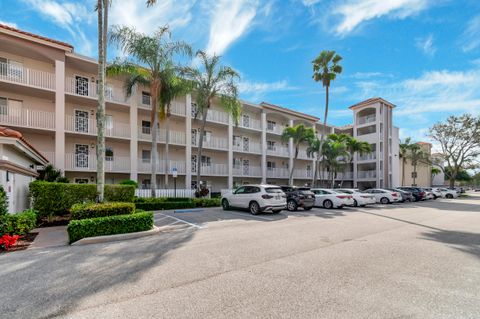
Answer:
96, 0, 108, 202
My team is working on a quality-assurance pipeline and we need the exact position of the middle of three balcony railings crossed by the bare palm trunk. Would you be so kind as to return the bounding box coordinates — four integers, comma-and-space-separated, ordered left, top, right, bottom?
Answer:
65, 115, 130, 138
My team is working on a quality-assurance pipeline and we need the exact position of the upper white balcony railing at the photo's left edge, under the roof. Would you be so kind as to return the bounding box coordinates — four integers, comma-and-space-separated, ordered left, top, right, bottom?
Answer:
0, 62, 55, 90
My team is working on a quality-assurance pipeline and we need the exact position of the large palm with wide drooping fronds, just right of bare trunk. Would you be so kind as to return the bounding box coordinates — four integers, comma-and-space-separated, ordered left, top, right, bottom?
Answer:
108, 26, 191, 197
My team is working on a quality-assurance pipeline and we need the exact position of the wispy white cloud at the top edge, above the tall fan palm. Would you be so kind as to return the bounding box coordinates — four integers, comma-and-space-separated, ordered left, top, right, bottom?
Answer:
333, 0, 428, 35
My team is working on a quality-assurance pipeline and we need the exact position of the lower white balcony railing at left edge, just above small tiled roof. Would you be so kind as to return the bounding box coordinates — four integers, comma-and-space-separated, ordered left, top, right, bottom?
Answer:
0, 107, 55, 130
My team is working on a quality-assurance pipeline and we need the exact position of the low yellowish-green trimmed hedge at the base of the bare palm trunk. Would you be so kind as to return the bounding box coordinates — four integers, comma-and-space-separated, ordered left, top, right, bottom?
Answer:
71, 202, 135, 220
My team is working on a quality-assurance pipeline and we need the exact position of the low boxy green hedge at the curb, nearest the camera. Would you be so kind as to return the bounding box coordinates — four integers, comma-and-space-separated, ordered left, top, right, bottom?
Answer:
67, 212, 153, 243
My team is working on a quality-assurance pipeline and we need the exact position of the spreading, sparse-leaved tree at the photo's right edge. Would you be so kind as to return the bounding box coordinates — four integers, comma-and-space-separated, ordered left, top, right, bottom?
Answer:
429, 114, 480, 187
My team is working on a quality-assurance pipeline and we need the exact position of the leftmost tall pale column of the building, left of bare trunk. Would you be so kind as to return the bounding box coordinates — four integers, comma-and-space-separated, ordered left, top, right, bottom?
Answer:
55, 60, 65, 171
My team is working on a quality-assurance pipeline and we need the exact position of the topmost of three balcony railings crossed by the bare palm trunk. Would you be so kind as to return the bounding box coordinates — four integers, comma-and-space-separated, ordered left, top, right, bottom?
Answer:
65, 77, 127, 103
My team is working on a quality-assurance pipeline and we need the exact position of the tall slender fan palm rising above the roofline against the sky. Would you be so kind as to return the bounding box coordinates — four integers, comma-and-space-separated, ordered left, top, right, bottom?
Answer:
312, 50, 343, 186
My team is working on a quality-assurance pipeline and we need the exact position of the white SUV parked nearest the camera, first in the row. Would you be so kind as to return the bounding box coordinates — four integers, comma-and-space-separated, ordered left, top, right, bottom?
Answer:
221, 185, 287, 215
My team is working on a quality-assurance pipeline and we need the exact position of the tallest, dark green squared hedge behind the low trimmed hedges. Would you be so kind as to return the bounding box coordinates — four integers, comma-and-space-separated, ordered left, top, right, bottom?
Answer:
30, 181, 97, 217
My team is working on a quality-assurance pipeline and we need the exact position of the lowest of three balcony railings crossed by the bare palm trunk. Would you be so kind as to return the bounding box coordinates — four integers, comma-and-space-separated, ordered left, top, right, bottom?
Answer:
65, 153, 130, 173
